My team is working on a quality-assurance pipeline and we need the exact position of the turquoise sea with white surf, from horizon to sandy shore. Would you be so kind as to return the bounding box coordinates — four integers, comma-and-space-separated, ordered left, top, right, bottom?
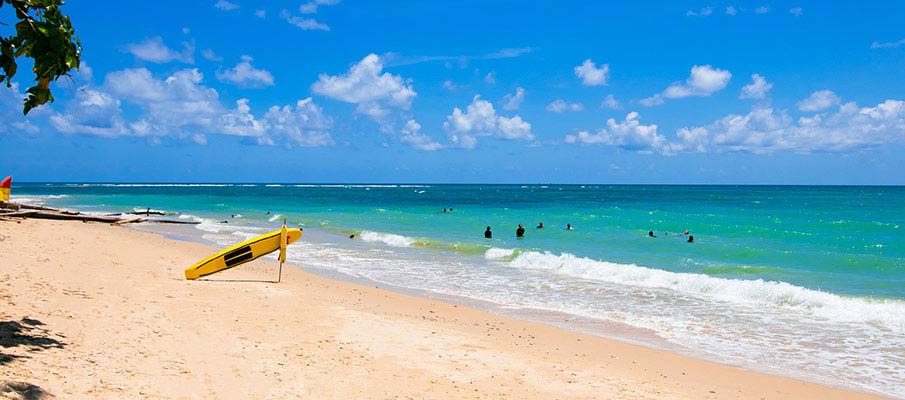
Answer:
13, 183, 905, 397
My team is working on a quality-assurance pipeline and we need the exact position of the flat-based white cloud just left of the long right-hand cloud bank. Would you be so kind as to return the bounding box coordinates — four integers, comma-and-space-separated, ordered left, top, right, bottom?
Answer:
565, 112, 673, 154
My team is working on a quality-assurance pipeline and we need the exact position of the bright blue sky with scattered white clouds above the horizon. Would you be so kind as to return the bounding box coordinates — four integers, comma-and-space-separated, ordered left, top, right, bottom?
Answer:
0, 0, 905, 184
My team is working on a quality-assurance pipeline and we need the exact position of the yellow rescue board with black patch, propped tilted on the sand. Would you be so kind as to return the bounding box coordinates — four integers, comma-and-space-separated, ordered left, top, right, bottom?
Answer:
185, 227, 302, 279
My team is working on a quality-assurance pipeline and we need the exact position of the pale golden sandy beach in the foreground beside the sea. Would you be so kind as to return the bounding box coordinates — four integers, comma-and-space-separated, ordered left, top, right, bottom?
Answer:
0, 220, 879, 399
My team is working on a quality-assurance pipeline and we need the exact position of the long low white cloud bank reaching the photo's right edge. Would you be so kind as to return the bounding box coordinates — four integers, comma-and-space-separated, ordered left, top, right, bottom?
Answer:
677, 100, 905, 153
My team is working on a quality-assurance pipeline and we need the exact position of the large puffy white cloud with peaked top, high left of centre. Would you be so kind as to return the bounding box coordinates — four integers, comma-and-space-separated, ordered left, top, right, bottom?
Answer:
311, 54, 417, 118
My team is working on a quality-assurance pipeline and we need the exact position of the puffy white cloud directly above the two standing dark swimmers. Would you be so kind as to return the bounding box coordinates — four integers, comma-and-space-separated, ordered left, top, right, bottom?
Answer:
443, 95, 534, 148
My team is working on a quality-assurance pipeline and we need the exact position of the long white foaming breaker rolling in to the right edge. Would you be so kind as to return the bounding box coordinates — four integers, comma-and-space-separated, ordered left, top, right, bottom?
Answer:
510, 252, 905, 330
